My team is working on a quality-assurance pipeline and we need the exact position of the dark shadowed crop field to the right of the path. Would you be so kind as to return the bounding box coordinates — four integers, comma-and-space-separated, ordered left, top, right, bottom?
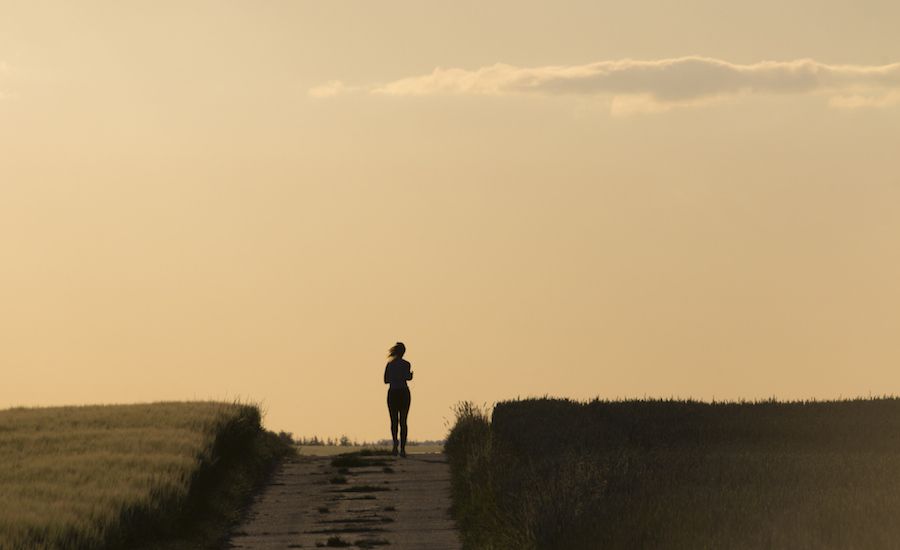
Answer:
446, 399, 900, 549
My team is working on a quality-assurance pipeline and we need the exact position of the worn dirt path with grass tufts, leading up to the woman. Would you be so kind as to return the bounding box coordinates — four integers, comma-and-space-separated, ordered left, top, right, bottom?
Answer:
229, 454, 461, 550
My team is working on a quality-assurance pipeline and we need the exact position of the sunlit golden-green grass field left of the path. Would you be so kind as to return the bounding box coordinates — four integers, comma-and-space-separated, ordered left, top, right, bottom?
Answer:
0, 402, 288, 549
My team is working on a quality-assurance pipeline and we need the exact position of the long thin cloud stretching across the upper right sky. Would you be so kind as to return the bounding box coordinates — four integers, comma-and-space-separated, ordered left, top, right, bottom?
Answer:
310, 56, 900, 114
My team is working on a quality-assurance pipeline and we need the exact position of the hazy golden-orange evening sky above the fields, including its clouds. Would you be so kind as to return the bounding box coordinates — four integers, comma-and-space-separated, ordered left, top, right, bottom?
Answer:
0, 0, 900, 440
